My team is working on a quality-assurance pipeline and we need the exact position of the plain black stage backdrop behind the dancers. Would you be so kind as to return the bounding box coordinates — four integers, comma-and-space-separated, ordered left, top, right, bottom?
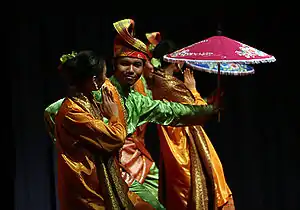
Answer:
10, 11, 300, 210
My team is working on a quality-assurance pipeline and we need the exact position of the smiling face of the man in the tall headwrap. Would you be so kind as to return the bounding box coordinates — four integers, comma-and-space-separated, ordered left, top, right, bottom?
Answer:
114, 57, 145, 86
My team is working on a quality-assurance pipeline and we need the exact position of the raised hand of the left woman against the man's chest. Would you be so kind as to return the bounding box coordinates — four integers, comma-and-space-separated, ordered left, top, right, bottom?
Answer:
100, 87, 119, 119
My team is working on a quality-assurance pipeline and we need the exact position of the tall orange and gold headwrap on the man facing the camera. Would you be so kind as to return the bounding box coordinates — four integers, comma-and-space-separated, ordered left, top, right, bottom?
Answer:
113, 19, 148, 60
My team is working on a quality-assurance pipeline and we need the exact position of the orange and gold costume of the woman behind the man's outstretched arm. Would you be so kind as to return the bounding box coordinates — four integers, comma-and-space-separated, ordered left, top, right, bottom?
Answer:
147, 32, 234, 210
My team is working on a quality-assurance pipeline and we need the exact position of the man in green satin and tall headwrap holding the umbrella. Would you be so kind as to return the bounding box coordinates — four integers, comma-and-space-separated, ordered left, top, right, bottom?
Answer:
45, 19, 217, 209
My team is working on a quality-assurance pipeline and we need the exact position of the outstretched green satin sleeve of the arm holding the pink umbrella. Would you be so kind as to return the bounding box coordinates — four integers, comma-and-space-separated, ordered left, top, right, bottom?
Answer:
126, 92, 214, 133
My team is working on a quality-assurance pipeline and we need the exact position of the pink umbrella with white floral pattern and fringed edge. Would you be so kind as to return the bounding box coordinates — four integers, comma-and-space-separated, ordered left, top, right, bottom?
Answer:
164, 36, 276, 119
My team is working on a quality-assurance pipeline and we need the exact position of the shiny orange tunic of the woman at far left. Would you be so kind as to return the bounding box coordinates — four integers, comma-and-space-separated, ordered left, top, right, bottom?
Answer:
55, 96, 133, 210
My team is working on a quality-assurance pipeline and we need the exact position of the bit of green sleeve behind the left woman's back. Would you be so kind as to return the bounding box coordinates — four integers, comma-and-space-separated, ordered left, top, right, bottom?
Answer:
44, 99, 64, 142
